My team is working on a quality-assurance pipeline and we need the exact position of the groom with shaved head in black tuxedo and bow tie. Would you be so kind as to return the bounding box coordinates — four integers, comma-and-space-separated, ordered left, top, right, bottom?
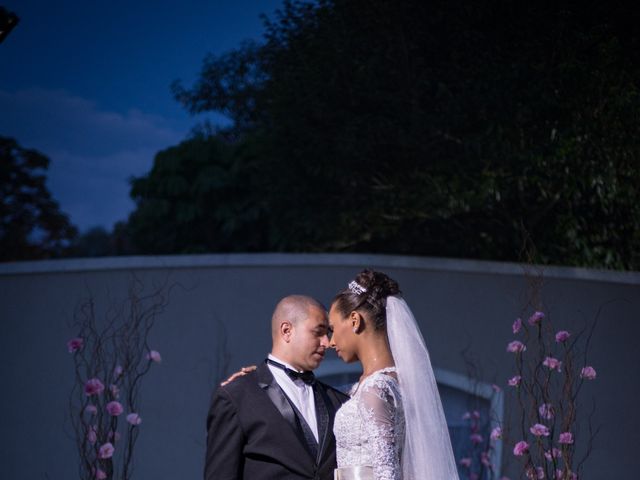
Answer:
204, 295, 348, 480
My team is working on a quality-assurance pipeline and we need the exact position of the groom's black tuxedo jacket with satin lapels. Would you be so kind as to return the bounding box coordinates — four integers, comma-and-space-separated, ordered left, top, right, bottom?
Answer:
204, 364, 348, 480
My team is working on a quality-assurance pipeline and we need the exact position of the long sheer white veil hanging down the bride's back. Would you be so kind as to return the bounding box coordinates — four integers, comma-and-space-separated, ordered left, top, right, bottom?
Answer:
386, 296, 458, 480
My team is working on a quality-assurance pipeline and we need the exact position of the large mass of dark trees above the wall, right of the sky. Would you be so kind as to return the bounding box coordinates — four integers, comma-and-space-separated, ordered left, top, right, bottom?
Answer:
130, 0, 640, 269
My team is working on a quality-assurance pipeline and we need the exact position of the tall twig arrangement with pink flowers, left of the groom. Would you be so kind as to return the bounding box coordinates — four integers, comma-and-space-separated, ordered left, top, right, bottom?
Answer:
67, 281, 168, 480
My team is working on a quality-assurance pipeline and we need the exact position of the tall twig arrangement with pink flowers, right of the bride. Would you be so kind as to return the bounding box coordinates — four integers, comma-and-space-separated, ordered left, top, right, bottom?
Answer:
506, 311, 596, 480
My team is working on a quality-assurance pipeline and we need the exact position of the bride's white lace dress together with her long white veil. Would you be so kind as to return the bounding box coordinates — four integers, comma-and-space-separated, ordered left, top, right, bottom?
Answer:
333, 296, 458, 480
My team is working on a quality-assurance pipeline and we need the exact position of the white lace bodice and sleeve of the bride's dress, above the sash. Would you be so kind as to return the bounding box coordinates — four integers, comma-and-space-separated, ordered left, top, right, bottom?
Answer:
333, 367, 405, 480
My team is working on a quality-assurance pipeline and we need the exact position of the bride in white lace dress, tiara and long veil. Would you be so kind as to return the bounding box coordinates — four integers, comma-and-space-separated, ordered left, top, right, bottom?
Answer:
329, 270, 458, 480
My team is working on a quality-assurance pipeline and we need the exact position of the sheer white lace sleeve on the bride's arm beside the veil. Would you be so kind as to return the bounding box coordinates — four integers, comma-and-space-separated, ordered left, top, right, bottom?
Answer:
359, 377, 404, 480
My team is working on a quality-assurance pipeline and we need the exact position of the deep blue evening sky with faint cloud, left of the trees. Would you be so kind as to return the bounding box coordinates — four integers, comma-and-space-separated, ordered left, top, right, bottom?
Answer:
0, 0, 282, 230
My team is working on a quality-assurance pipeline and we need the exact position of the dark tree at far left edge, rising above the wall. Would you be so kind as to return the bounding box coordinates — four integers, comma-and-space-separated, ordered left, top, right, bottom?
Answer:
0, 136, 77, 261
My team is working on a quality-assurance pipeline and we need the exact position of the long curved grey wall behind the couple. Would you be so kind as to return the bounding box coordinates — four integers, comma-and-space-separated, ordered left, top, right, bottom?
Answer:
0, 254, 640, 480
